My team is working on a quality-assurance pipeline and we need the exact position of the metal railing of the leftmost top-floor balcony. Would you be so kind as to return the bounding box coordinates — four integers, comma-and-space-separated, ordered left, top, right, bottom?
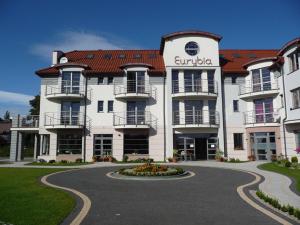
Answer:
45, 80, 85, 97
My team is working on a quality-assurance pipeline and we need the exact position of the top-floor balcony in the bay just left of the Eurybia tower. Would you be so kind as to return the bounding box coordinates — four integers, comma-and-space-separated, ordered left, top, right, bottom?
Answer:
114, 81, 156, 98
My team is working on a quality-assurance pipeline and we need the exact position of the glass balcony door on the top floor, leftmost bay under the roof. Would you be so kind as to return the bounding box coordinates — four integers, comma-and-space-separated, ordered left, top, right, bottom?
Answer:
61, 72, 80, 94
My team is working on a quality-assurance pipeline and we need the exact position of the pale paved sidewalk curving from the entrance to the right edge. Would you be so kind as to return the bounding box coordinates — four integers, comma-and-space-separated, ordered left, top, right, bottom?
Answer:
180, 161, 300, 208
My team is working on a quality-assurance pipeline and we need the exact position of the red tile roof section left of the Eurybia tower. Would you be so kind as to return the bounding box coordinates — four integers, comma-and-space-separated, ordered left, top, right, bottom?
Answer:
36, 50, 165, 76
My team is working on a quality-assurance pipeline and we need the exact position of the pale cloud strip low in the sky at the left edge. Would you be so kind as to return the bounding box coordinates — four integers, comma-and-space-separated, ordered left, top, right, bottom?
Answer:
0, 90, 33, 105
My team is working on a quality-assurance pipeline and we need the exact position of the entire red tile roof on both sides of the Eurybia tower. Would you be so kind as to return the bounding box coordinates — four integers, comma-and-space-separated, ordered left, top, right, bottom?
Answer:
36, 49, 278, 76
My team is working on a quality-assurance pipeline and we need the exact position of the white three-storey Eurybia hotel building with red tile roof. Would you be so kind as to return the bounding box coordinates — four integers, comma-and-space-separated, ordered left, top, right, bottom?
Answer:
10, 31, 300, 161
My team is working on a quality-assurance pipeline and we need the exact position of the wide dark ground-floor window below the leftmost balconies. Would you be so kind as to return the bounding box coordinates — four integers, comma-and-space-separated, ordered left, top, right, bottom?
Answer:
57, 134, 82, 154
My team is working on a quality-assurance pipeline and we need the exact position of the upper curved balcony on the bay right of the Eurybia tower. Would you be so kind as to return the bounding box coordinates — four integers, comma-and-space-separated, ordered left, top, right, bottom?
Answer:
239, 80, 279, 99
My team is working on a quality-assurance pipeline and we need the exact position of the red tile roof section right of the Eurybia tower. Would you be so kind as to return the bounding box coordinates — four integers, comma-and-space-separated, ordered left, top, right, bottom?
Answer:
220, 49, 278, 74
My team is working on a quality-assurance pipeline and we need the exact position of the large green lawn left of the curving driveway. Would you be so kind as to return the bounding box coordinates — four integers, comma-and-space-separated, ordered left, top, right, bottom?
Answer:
0, 168, 76, 225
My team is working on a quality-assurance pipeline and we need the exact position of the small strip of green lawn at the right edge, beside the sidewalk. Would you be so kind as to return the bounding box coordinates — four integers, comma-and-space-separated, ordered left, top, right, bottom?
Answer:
258, 163, 300, 192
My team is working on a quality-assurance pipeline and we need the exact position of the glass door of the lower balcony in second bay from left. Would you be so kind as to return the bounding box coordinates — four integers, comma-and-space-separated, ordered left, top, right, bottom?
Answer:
126, 101, 146, 125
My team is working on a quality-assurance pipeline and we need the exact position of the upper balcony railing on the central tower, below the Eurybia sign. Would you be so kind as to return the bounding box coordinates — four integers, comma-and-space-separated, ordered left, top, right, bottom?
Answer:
172, 79, 218, 94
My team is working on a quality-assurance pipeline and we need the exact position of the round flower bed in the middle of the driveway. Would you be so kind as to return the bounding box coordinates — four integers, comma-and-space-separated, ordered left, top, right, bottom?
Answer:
118, 163, 185, 176
